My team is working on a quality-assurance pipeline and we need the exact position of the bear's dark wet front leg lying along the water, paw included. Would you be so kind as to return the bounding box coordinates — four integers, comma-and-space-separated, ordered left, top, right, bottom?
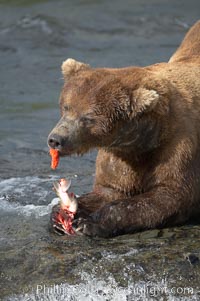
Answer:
74, 186, 191, 237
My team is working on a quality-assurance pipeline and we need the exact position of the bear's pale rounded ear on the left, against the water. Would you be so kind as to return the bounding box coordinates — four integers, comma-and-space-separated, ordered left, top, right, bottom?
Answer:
61, 59, 90, 79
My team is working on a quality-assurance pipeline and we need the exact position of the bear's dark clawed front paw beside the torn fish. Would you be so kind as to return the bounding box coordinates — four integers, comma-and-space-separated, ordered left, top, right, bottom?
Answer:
73, 218, 111, 237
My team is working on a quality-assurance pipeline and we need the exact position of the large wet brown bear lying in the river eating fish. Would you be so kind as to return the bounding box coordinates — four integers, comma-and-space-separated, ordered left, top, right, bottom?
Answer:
48, 21, 200, 237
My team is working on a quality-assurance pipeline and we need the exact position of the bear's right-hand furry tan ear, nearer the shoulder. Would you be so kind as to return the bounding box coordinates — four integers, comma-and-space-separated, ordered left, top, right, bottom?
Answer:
131, 88, 159, 116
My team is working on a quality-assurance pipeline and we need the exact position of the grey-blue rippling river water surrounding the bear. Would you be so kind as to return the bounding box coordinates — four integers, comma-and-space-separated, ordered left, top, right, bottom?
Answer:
0, 0, 200, 301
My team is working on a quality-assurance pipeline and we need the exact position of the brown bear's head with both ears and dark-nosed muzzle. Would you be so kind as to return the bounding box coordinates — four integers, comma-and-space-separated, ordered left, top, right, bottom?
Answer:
48, 59, 170, 155
